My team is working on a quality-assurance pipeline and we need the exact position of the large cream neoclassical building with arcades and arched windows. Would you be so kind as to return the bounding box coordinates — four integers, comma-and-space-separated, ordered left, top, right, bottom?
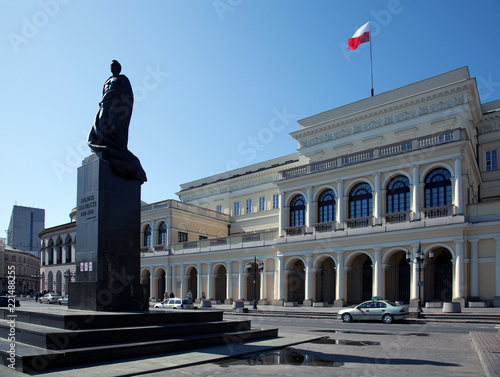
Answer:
141, 68, 500, 306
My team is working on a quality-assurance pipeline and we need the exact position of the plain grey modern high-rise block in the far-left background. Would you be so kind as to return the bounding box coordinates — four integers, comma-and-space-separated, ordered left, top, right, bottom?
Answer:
7, 205, 45, 257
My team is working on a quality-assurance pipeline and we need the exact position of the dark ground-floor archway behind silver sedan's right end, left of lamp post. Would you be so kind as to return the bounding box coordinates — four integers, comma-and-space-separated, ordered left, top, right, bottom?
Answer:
385, 250, 411, 304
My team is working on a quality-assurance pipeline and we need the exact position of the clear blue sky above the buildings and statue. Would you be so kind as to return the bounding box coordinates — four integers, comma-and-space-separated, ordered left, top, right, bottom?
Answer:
0, 0, 500, 237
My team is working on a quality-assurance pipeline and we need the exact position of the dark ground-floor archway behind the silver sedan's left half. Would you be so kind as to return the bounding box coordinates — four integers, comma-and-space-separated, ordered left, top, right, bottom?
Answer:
347, 254, 373, 305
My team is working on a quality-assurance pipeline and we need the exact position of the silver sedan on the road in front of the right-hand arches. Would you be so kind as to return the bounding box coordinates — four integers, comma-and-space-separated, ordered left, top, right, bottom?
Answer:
337, 297, 410, 323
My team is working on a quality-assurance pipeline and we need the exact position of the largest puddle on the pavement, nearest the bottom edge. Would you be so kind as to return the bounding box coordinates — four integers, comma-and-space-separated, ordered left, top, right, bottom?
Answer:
215, 348, 344, 368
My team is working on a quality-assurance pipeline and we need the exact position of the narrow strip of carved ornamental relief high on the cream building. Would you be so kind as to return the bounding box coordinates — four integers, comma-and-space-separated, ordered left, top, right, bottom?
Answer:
299, 95, 466, 149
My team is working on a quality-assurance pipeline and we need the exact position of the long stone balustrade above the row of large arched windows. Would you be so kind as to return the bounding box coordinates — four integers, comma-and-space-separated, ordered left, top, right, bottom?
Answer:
280, 129, 467, 180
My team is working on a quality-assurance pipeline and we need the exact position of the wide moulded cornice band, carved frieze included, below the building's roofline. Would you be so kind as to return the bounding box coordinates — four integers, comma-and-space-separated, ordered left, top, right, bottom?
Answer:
291, 84, 470, 150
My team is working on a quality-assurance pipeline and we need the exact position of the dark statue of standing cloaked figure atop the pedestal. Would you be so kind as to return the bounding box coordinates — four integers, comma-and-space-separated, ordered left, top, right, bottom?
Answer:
87, 60, 147, 183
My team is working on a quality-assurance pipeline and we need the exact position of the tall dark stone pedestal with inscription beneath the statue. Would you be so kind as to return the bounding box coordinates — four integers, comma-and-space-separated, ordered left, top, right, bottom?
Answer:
68, 154, 149, 312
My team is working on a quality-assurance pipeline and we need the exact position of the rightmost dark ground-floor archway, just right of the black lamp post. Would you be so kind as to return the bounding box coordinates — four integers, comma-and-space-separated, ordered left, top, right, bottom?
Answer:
424, 248, 453, 302
